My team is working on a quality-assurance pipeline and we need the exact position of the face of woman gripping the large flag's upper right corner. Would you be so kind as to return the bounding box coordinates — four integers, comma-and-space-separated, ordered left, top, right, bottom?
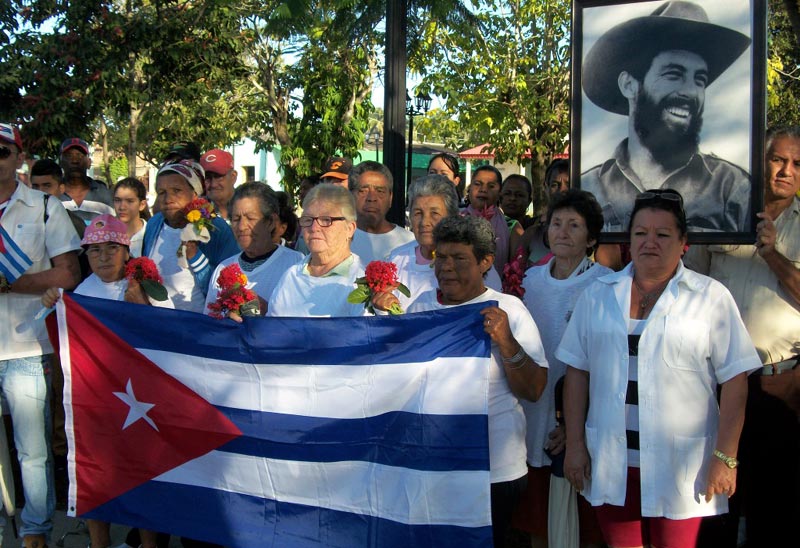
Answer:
433, 242, 494, 304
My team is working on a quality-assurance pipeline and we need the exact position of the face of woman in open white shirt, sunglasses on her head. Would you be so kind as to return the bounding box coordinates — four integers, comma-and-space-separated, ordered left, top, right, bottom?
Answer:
631, 208, 686, 276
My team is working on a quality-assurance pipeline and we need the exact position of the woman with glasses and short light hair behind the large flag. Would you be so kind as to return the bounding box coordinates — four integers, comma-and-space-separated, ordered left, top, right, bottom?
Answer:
267, 185, 364, 317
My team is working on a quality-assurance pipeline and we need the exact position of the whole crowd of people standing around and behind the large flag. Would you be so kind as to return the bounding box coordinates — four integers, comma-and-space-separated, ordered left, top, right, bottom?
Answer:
0, 116, 800, 548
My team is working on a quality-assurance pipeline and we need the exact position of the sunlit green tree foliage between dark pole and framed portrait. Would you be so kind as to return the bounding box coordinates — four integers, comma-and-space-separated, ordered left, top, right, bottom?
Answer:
419, 0, 570, 171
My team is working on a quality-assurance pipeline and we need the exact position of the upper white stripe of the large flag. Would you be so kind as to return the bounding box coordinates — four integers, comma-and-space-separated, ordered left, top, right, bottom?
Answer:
139, 349, 488, 419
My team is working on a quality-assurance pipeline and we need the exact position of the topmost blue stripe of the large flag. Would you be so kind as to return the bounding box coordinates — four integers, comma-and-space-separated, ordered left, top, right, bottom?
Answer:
72, 295, 496, 365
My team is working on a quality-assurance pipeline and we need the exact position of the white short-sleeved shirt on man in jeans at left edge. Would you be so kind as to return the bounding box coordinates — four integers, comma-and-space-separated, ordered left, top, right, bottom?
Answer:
0, 184, 80, 360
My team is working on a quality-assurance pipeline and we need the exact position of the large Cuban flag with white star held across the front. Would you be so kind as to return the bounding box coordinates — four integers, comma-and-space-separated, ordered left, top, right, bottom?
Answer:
57, 295, 492, 548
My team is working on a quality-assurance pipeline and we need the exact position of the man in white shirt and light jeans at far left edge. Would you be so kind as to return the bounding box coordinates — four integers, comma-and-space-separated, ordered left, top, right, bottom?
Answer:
0, 124, 80, 548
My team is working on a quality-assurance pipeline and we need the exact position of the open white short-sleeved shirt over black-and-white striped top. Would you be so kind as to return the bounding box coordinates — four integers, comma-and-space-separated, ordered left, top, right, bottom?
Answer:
556, 263, 761, 519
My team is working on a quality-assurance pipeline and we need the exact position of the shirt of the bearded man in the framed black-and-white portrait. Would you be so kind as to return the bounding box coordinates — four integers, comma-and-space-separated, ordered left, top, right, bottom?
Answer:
581, 139, 752, 232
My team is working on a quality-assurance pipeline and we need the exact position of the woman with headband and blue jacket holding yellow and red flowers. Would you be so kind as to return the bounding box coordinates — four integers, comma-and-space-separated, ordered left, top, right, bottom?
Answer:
142, 160, 239, 312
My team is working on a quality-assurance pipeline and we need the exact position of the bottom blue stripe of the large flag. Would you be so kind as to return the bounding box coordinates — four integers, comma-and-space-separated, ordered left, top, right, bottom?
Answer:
85, 481, 492, 548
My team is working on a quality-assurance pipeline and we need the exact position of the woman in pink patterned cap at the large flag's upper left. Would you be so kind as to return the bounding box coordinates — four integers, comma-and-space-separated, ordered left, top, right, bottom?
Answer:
42, 214, 173, 548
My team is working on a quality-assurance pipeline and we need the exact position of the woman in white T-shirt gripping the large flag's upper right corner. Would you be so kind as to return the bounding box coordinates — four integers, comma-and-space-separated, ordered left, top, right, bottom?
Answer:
409, 217, 547, 547
